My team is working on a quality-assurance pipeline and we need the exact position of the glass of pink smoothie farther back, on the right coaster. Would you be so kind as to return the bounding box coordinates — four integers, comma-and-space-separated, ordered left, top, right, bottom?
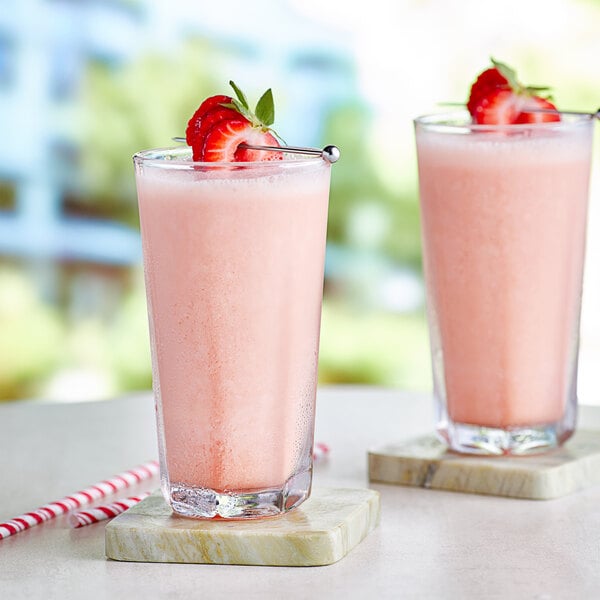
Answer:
415, 113, 593, 455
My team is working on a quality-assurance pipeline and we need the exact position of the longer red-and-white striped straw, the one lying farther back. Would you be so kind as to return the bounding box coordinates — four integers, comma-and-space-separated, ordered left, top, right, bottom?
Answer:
0, 460, 158, 540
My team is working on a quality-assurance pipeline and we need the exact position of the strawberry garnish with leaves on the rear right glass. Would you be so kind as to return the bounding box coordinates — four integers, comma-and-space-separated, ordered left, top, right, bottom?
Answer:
467, 59, 560, 125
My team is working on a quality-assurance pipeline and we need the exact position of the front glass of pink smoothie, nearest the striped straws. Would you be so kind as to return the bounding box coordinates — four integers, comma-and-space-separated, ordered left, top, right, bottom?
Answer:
134, 148, 330, 518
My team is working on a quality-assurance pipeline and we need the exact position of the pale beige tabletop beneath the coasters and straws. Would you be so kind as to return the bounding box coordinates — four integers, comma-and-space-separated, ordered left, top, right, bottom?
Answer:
0, 387, 600, 600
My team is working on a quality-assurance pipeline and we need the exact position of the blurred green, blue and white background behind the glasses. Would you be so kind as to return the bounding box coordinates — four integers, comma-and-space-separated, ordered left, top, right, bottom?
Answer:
0, 0, 600, 402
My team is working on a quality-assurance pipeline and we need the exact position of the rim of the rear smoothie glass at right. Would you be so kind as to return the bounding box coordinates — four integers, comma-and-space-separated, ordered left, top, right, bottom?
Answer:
413, 110, 594, 133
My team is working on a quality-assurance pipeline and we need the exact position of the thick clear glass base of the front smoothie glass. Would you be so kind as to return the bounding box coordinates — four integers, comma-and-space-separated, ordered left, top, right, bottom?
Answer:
165, 470, 312, 519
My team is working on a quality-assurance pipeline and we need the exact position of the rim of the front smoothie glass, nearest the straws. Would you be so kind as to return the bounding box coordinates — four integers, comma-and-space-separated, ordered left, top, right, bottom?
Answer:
132, 146, 330, 170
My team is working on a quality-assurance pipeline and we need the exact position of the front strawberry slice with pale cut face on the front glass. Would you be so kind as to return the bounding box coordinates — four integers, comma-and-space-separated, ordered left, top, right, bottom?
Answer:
199, 119, 282, 162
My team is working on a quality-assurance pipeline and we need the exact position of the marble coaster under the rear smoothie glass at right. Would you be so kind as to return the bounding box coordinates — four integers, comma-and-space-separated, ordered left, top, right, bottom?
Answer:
369, 430, 600, 500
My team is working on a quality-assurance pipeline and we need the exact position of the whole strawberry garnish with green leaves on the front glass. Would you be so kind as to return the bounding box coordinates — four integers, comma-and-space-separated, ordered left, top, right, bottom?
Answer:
186, 81, 282, 162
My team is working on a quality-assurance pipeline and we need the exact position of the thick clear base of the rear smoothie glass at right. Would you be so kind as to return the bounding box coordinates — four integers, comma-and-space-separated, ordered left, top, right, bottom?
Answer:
438, 423, 573, 456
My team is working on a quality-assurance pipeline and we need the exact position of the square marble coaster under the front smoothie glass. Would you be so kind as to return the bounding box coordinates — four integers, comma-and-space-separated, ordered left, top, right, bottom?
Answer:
105, 488, 379, 566
